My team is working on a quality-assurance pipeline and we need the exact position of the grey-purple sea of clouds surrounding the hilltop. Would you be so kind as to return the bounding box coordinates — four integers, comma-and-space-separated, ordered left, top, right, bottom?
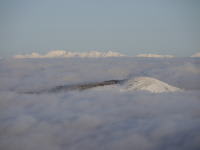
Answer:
0, 57, 200, 150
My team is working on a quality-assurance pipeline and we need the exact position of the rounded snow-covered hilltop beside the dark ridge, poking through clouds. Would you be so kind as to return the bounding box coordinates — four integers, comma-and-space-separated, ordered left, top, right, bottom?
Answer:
122, 77, 182, 93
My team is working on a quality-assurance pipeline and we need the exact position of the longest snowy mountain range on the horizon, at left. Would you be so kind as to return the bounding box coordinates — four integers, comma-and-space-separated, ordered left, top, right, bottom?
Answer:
14, 50, 125, 59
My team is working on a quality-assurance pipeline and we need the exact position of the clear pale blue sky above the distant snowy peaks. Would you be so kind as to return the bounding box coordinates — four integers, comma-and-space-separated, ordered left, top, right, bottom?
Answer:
0, 0, 200, 57
